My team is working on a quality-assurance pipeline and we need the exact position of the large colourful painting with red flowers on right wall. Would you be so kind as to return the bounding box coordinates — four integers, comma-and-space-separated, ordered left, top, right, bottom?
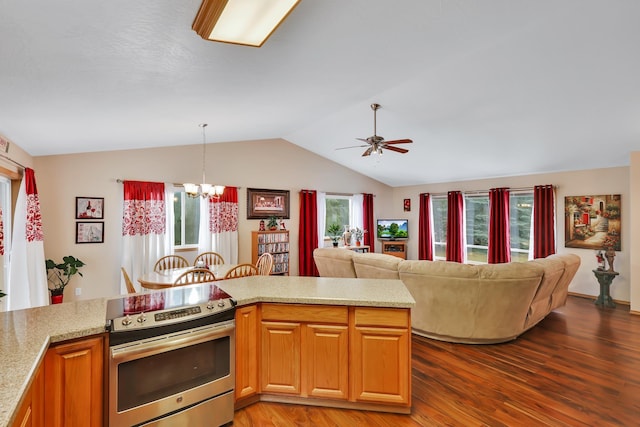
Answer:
564, 194, 621, 251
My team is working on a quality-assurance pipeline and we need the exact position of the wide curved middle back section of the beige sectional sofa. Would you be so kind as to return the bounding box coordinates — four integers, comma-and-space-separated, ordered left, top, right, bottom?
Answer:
398, 261, 544, 343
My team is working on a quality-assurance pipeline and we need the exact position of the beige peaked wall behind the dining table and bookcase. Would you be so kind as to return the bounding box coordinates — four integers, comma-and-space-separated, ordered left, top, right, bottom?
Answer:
34, 139, 392, 301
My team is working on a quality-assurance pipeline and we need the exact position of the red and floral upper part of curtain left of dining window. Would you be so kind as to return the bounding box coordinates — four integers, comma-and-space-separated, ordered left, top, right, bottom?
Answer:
122, 181, 166, 236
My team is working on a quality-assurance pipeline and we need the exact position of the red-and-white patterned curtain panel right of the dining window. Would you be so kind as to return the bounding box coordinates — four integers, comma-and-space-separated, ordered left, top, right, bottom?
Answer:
198, 187, 238, 264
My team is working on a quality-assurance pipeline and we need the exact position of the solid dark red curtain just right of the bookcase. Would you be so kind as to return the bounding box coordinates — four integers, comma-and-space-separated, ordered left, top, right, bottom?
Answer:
298, 190, 320, 276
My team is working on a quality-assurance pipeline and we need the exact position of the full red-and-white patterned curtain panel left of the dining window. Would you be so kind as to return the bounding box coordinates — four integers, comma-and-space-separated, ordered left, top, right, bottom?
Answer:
120, 181, 174, 294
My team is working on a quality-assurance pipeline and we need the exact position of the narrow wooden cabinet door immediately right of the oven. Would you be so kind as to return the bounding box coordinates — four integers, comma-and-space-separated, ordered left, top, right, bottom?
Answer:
236, 305, 258, 400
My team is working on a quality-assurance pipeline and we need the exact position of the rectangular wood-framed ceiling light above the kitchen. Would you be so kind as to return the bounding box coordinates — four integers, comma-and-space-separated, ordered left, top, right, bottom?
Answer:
191, 0, 300, 47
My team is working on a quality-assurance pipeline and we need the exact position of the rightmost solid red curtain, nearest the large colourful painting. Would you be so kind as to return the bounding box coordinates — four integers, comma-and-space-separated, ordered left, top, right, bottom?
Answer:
533, 185, 556, 258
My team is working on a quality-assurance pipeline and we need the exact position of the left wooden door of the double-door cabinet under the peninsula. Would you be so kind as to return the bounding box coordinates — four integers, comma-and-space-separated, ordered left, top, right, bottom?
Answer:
261, 322, 301, 395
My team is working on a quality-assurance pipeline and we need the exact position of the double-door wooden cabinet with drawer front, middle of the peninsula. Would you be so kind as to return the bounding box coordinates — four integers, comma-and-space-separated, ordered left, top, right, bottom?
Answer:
261, 304, 349, 399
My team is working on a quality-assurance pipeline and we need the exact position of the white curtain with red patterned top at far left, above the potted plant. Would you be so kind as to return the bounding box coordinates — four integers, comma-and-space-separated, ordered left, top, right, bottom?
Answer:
5, 168, 49, 310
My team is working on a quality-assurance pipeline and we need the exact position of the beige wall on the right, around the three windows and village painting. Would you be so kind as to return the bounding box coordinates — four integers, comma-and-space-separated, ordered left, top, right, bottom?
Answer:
390, 166, 640, 302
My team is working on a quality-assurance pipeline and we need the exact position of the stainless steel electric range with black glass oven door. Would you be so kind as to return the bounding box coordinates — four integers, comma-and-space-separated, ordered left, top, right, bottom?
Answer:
107, 284, 236, 427
